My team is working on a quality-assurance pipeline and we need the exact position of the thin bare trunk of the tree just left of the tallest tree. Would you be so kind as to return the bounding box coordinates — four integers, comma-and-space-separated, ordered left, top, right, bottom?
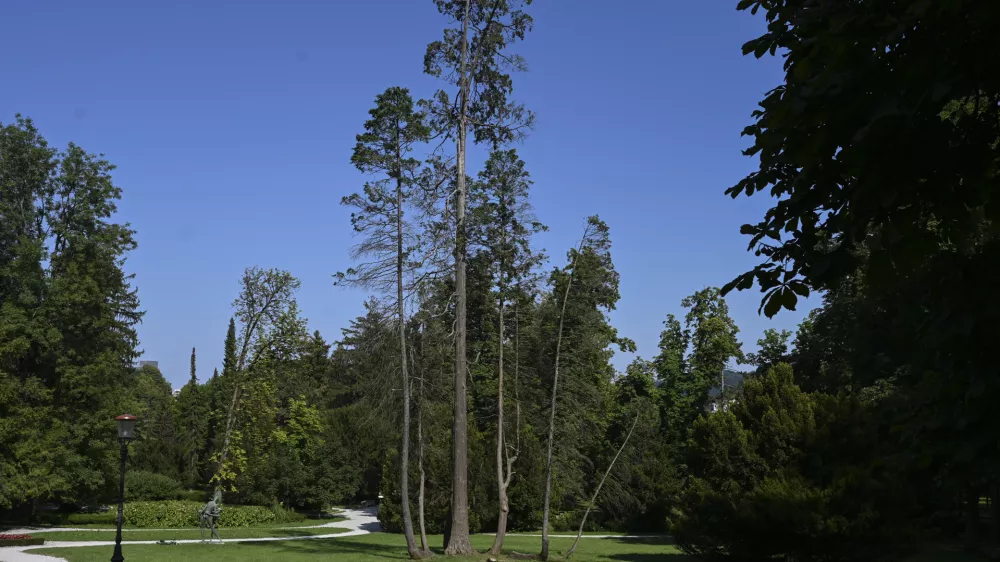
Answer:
396, 174, 420, 558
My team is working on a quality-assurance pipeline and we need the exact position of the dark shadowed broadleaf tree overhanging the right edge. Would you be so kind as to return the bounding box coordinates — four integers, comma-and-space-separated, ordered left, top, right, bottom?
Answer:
726, 0, 1000, 546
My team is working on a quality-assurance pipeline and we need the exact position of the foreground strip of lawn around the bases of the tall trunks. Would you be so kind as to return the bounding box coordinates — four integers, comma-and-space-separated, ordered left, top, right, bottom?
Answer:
31, 533, 695, 562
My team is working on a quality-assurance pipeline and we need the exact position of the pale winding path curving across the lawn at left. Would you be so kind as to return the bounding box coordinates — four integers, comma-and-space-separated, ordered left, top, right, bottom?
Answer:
0, 507, 382, 562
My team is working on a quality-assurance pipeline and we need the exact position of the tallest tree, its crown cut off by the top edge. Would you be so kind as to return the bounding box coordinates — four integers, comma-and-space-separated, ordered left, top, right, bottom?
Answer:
424, 0, 532, 555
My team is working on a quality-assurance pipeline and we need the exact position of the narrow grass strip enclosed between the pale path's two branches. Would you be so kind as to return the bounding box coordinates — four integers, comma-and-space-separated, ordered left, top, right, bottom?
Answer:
32, 525, 347, 541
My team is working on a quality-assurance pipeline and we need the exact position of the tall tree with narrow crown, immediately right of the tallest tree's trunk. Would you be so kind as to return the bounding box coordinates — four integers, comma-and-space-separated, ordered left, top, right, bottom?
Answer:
472, 150, 545, 554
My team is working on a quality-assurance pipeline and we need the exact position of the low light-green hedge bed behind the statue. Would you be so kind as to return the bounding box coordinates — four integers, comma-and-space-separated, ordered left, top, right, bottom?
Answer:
124, 500, 278, 528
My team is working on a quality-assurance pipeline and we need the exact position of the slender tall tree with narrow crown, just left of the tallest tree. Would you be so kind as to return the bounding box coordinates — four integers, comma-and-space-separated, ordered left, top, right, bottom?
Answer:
337, 87, 430, 558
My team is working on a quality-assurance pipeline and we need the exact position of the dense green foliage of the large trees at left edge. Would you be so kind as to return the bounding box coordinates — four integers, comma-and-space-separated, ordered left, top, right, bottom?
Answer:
0, 115, 142, 507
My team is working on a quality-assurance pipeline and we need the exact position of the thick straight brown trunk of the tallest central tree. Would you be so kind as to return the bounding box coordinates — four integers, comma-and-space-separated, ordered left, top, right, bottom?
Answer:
445, 0, 476, 556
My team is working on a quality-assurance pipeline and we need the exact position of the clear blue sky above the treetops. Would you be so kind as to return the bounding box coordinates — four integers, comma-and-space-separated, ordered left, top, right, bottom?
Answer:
0, 0, 816, 386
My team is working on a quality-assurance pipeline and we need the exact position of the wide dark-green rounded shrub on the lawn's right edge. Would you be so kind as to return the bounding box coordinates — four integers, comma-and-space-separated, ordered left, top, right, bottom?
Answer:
673, 364, 912, 561
